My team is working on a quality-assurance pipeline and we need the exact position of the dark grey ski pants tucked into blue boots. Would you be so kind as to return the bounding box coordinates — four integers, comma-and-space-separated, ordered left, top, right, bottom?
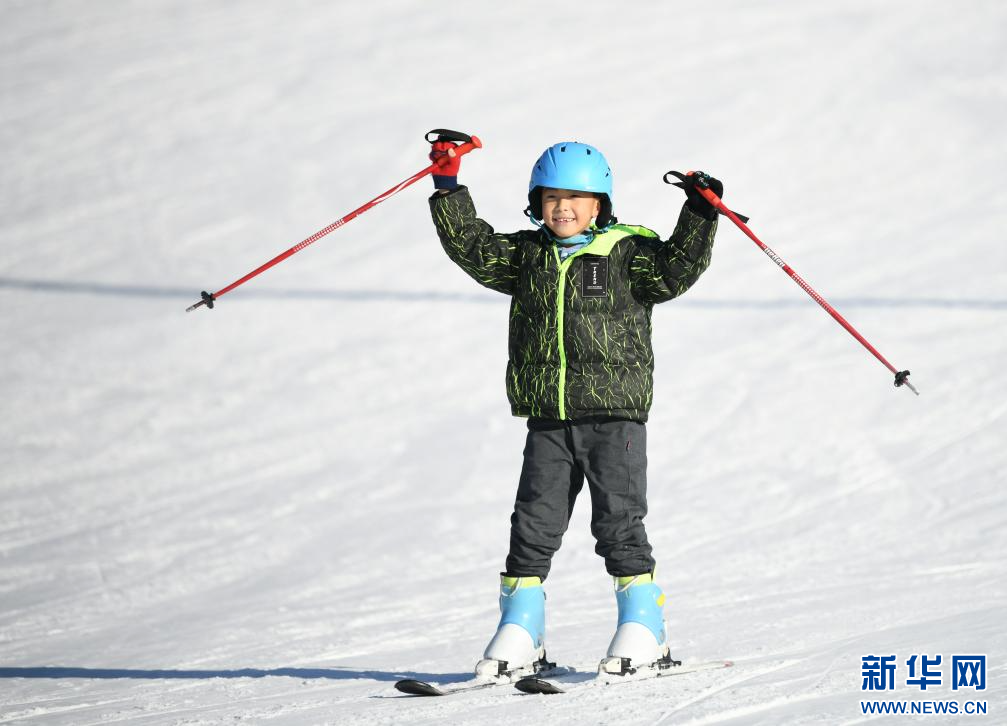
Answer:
507, 417, 654, 580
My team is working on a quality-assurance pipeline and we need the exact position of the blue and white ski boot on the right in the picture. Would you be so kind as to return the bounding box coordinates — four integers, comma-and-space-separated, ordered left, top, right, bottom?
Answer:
598, 573, 671, 676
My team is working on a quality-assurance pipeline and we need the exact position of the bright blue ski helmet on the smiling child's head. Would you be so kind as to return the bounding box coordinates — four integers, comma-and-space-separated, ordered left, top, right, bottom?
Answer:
528, 141, 615, 228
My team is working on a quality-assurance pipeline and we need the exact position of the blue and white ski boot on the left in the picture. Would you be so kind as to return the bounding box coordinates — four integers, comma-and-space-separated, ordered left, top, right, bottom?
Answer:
475, 575, 553, 680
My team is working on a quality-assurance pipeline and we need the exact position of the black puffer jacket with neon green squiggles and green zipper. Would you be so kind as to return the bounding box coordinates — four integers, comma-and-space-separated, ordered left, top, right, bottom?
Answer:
430, 186, 717, 421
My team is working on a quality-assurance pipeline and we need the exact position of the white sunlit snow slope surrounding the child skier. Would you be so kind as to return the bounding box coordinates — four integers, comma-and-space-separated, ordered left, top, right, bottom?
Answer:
0, 0, 1007, 725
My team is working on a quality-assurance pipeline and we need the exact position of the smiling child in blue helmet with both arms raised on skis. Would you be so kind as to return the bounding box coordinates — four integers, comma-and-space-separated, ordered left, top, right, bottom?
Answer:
430, 139, 723, 678
